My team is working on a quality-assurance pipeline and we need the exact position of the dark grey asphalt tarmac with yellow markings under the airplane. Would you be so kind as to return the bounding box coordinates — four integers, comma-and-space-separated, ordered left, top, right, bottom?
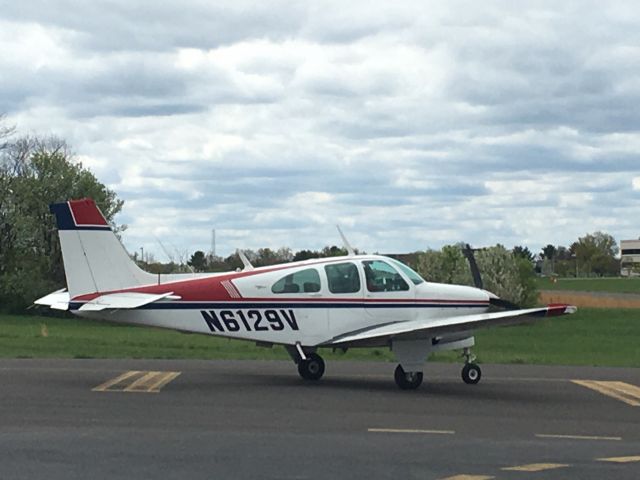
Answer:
0, 359, 640, 480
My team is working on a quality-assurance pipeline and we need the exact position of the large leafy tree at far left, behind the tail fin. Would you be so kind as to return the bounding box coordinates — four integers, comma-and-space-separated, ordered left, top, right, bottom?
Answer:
0, 133, 123, 310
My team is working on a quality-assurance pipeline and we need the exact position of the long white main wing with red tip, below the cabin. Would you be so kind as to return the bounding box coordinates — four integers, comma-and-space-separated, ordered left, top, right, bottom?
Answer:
324, 305, 577, 346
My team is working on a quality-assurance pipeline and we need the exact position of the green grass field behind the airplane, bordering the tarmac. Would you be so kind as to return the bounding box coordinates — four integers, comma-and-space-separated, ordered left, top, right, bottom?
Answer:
0, 309, 640, 367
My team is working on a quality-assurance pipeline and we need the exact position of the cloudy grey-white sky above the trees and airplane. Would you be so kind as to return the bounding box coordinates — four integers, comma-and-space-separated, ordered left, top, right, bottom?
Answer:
0, 0, 640, 260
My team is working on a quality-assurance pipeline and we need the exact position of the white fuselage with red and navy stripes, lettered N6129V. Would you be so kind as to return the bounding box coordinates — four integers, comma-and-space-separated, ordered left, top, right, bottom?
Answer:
70, 255, 490, 346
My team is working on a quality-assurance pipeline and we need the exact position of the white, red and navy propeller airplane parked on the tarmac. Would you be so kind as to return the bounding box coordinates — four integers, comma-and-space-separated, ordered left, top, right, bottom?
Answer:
34, 198, 577, 390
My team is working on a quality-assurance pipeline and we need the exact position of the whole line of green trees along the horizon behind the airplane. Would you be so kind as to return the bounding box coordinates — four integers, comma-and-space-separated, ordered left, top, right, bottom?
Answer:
0, 116, 620, 311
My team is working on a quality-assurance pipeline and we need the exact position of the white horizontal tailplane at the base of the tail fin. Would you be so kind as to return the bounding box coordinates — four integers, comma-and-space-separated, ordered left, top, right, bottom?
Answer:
33, 290, 180, 312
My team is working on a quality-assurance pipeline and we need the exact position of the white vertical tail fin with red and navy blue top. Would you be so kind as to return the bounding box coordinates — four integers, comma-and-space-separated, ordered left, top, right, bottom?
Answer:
49, 198, 155, 298
